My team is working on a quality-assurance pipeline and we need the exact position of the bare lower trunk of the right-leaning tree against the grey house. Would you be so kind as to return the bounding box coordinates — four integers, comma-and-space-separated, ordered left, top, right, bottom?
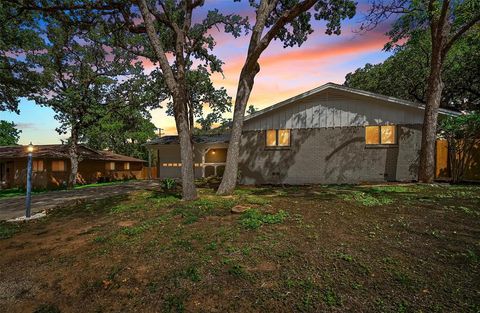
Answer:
217, 63, 260, 195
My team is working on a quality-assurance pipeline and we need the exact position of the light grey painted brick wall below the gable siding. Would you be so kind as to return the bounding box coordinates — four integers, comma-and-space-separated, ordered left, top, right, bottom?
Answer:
239, 125, 421, 184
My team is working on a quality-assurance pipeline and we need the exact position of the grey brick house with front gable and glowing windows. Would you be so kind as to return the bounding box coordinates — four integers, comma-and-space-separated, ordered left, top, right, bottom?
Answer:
148, 83, 458, 184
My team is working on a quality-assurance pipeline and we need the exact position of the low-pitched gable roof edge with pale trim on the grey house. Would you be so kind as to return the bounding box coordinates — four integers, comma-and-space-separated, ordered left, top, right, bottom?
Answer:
244, 83, 461, 122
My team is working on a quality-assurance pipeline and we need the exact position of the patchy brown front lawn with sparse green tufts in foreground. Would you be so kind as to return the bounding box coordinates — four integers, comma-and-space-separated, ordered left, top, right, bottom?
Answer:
0, 185, 480, 312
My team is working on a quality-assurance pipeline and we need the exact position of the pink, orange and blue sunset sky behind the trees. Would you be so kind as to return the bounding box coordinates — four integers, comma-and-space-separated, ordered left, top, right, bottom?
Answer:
0, 0, 390, 144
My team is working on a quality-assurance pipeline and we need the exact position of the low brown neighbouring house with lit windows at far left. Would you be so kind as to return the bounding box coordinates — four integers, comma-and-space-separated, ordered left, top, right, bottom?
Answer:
0, 144, 145, 189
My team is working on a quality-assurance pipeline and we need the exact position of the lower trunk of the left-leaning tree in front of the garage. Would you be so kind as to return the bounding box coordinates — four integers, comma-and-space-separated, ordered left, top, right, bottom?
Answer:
173, 87, 197, 200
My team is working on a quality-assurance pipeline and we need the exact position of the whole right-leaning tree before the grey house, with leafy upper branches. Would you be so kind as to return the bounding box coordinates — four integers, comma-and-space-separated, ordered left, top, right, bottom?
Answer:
217, 0, 355, 195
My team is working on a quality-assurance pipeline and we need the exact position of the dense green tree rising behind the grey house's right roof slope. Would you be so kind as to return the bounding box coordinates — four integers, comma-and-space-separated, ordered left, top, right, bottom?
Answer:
344, 27, 480, 110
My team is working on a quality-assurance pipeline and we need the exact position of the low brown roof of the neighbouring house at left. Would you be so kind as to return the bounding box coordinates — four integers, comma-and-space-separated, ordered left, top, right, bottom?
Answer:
0, 144, 145, 162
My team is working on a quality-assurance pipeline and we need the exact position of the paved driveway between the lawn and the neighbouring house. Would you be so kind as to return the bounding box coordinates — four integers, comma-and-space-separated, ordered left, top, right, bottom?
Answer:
0, 180, 159, 220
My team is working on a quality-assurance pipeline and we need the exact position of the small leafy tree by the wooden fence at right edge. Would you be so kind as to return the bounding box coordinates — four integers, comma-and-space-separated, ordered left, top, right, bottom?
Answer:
439, 112, 480, 183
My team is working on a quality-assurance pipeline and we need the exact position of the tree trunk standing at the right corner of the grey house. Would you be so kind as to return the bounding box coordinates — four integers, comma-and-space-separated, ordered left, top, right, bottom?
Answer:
418, 43, 443, 183
